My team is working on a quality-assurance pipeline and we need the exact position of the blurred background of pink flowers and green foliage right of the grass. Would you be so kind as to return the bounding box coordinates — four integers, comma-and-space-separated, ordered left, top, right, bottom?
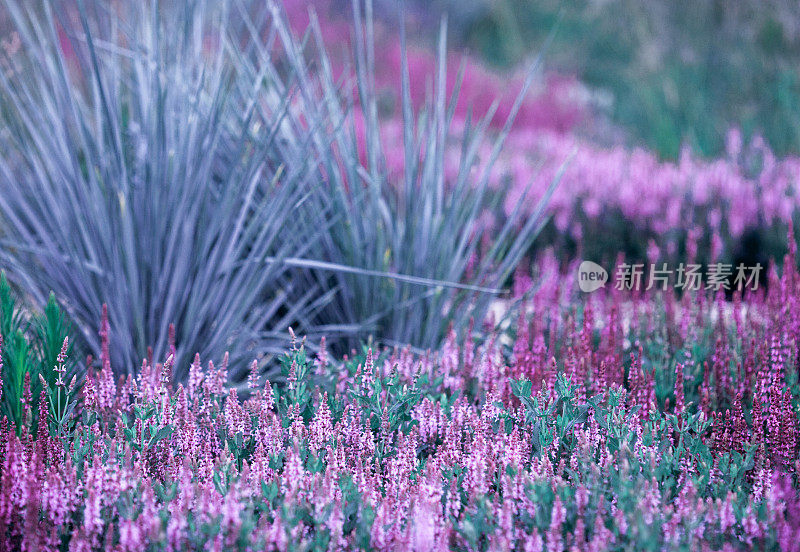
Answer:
287, 0, 800, 270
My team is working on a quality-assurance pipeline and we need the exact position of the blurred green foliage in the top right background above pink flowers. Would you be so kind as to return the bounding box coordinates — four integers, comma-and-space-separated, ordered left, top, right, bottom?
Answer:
461, 0, 800, 158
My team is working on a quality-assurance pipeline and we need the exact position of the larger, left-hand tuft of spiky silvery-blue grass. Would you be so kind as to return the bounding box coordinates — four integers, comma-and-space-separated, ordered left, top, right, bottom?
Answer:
0, 0, 324, 377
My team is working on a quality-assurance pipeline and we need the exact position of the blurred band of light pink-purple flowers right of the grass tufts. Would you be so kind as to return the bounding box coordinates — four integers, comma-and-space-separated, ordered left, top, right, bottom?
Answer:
496, 130, 800, 260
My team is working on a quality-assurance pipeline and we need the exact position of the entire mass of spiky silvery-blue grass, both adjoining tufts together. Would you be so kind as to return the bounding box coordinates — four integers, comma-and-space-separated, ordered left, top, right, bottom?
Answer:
0, 0, 556, 379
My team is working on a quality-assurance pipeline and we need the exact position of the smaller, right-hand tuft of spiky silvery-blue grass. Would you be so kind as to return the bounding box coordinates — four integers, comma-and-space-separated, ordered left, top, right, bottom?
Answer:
260, 0, 557, 349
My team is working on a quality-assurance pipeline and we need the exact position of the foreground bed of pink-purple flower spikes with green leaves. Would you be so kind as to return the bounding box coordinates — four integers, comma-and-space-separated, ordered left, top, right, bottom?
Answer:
0, 248, 800, 551
